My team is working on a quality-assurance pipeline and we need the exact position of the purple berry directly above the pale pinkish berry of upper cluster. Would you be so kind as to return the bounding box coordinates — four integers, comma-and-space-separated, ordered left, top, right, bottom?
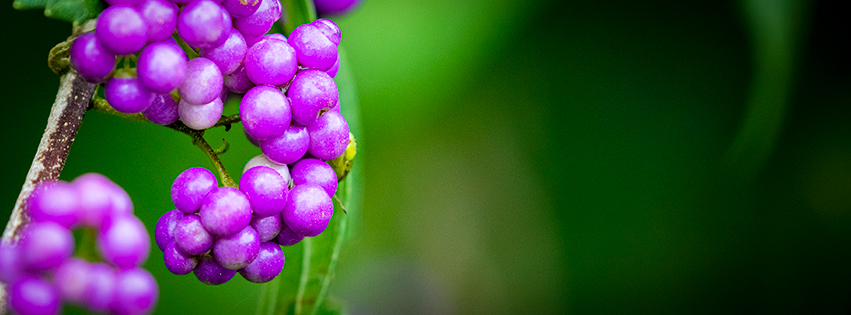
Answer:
177, 57, 222, 105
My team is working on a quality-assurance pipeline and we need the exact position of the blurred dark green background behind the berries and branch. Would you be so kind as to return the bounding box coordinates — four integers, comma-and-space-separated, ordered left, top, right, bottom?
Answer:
0, 0, 851, 314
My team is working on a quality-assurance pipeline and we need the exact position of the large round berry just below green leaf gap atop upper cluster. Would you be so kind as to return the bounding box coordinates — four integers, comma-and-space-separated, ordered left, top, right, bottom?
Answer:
243, 39, 298, 85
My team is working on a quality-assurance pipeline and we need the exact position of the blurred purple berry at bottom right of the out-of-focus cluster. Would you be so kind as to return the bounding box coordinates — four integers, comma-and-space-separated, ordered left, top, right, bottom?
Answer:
111, 268, 159, 315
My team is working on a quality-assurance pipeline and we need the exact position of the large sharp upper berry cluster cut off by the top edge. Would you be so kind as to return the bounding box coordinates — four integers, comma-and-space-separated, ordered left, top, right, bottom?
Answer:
69, 0, 341, 133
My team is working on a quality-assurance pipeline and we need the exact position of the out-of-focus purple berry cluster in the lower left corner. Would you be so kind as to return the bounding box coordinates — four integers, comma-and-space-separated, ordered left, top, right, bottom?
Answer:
0, 173, 158, 314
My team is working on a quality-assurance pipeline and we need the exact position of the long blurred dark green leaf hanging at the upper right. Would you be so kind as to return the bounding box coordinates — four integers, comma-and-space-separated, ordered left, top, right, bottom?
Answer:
726, 0, 809, 183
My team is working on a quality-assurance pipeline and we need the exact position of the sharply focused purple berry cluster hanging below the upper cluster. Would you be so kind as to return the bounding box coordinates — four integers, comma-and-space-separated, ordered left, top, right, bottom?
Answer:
154, 155, 337, 285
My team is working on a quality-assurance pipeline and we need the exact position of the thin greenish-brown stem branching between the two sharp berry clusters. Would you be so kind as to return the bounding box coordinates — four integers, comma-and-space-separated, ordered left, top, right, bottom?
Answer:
89, 97, 240, 188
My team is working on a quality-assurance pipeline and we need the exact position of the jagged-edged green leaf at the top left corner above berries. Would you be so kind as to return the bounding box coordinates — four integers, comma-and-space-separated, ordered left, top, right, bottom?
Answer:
12, 0, 103, 25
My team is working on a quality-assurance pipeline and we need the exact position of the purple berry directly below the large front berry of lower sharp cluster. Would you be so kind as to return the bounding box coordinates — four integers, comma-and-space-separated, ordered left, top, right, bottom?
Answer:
213, 226, 260, 270
